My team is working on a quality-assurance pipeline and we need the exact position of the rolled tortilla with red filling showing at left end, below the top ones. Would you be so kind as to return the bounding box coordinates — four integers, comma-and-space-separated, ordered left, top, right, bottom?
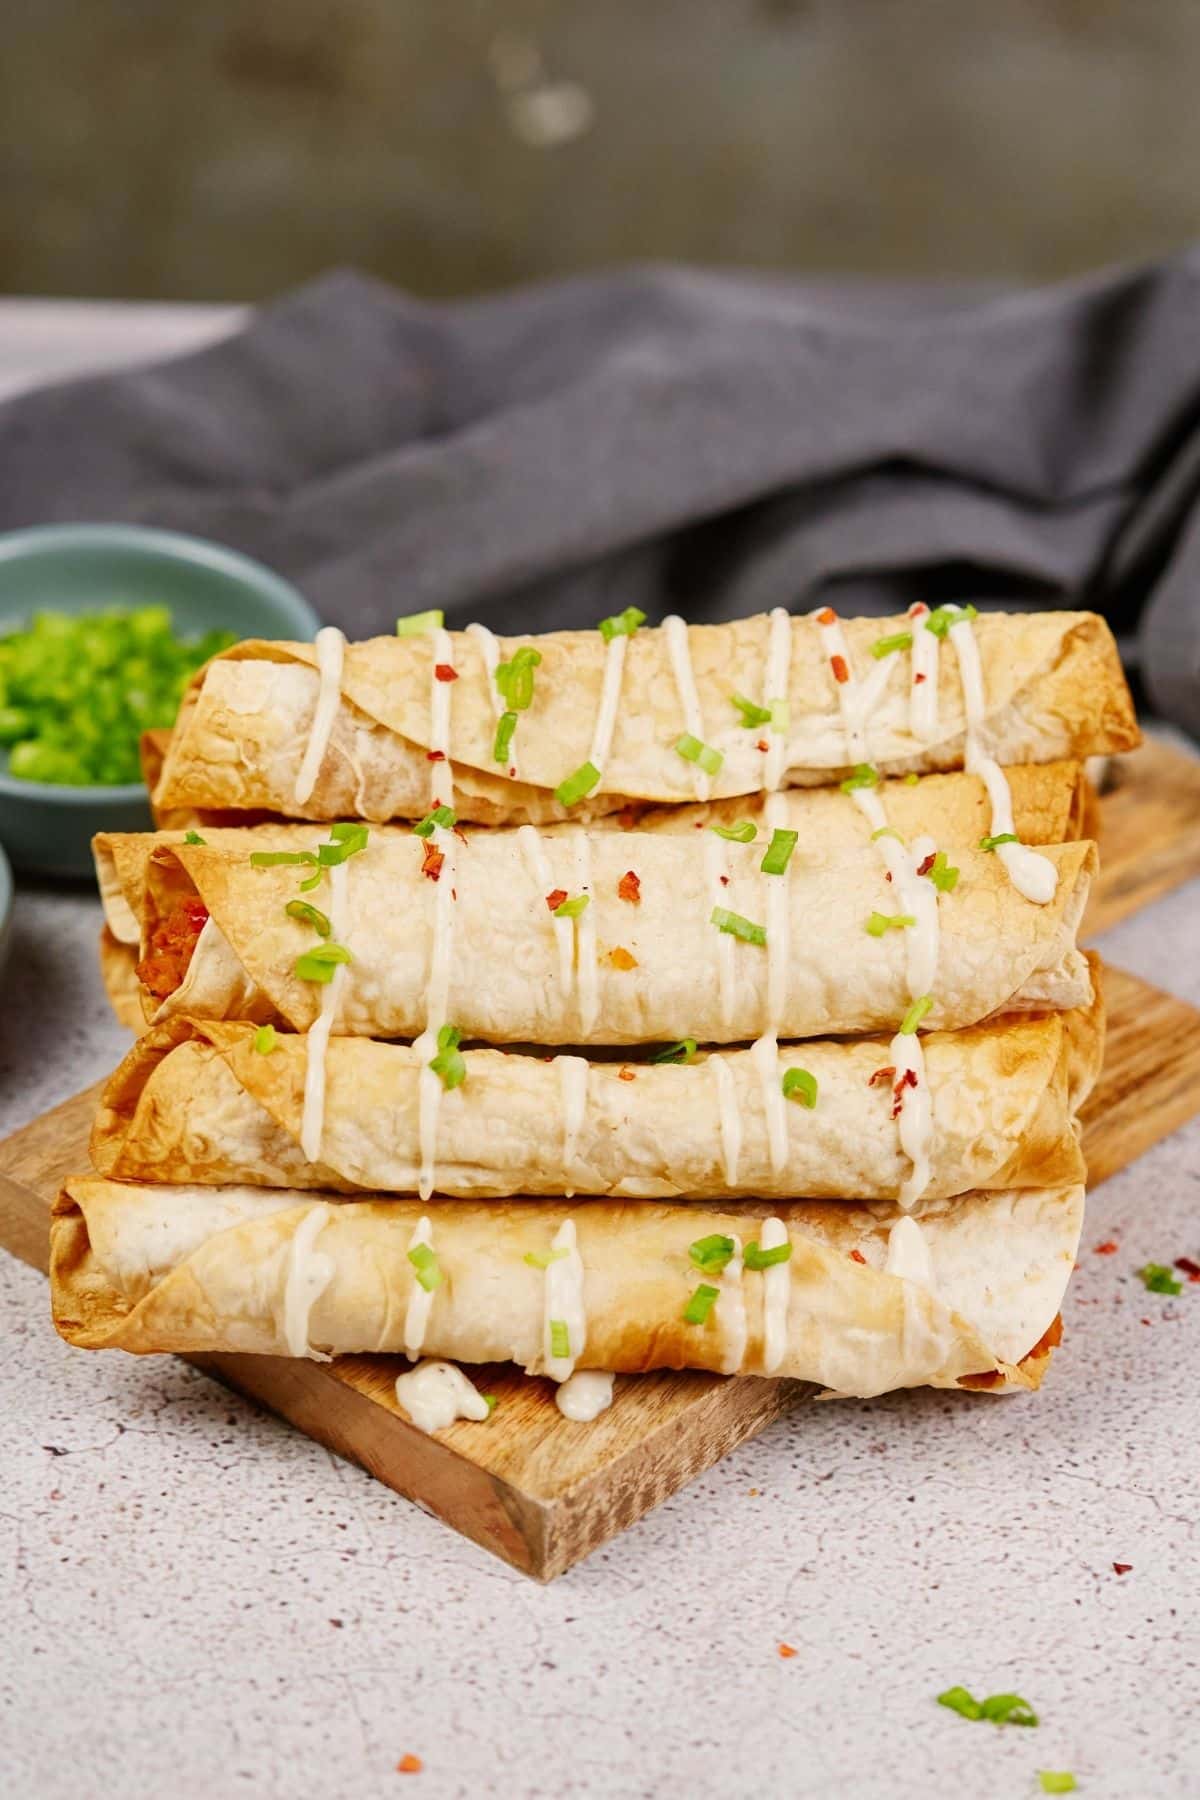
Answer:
146, 830, 1096, 1044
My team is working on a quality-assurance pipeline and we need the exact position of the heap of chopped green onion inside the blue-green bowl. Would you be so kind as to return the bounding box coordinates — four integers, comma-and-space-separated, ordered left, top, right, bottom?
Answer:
0, 607, 236, 787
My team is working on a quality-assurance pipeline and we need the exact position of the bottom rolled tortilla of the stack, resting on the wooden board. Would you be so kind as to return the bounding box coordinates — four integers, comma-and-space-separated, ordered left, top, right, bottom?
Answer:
50, 1177, 1083, 1395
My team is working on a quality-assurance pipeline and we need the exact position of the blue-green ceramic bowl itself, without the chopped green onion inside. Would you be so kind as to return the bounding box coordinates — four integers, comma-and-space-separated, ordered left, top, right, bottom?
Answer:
0, 526, 320, 875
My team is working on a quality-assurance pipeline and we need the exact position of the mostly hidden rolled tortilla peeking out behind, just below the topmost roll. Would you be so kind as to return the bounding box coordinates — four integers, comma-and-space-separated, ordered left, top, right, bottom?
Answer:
92, 756, 1096, 943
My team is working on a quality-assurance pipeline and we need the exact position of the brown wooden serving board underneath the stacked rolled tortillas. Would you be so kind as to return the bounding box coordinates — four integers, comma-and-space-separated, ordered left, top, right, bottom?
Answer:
0, 743, 1200, 1580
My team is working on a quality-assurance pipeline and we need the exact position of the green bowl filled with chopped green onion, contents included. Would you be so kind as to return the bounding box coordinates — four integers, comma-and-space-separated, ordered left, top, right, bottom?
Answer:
0, 526, 320, 875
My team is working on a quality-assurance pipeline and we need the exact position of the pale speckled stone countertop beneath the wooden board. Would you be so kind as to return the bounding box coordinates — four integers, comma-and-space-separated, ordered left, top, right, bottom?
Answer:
0, 306, 1200, 1800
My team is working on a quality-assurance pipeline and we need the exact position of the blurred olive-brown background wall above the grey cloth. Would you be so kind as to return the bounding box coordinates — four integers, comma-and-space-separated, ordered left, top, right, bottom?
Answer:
0, 0, 1200, 301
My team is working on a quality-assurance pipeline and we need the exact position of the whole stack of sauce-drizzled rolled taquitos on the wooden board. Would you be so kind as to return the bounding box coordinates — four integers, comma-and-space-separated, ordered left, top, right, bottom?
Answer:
54, 608, 1135, 1424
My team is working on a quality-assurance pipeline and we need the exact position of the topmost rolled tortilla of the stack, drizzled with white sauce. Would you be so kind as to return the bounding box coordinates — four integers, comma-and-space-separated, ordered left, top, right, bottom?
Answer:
153, 612, 1139, 824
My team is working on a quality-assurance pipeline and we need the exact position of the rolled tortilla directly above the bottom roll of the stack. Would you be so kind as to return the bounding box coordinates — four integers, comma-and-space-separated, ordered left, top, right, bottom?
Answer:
92, 997, 1103, 1199
